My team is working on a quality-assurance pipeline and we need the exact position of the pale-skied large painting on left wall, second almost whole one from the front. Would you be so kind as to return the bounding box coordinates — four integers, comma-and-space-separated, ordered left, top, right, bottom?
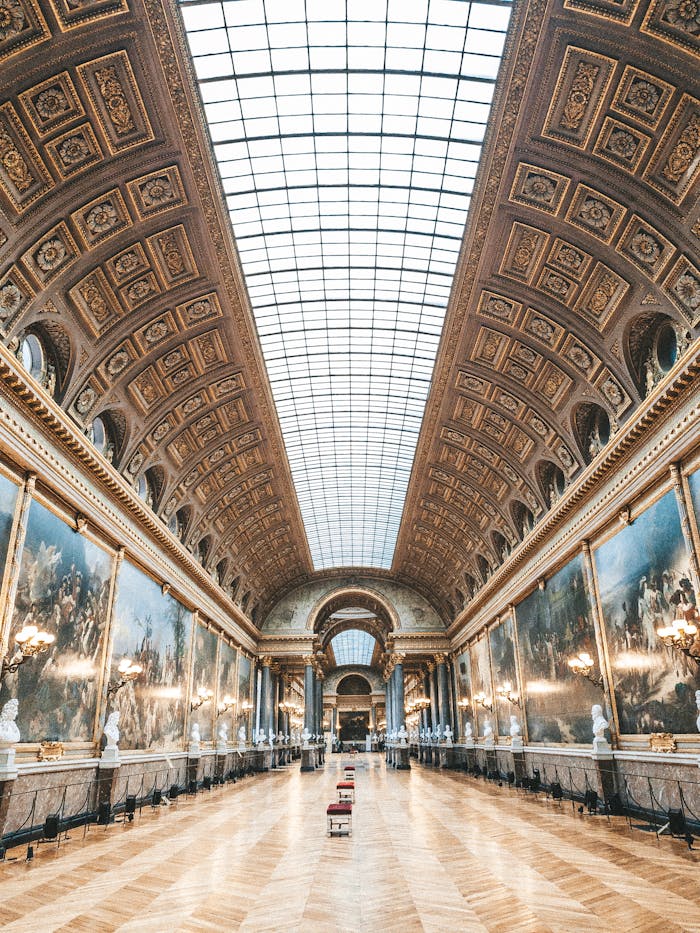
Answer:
112, 561, 192, 751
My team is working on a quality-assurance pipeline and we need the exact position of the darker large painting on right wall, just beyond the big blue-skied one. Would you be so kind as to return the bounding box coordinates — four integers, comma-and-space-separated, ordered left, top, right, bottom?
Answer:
515, 555, 603, 744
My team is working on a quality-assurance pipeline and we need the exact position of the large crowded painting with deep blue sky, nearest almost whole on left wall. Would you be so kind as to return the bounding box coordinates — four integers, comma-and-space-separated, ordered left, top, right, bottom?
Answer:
0, 500, 113, 742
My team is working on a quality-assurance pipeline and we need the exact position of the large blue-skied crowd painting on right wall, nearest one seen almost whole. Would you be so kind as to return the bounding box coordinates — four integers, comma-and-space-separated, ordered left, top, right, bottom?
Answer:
595, 491, 698, 735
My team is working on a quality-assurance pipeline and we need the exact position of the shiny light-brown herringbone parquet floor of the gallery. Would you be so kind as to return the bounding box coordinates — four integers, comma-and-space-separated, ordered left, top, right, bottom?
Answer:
0, 755, 700, 933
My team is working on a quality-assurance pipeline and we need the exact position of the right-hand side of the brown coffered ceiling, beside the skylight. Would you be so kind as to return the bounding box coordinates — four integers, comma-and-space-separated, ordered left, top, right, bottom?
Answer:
393, 0, 700, 612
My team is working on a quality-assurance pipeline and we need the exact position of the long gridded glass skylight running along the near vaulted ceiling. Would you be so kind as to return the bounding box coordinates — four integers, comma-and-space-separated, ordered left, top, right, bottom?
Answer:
181, 0, 510, 569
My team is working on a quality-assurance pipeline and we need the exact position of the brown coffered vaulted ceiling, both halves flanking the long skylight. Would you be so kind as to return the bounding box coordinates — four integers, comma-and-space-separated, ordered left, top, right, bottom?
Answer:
0, 0, 700, 628
